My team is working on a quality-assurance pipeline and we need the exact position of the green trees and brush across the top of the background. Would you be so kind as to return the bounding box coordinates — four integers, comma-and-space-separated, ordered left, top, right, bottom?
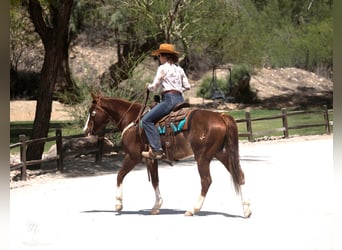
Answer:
10, 0, 333, 103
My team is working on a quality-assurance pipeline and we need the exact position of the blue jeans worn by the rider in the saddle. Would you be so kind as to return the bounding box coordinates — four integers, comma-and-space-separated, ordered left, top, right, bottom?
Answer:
141, 93, 184, 151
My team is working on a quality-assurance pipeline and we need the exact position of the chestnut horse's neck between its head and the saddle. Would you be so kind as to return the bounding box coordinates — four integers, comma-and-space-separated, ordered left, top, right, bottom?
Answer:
101, 99, 141, 130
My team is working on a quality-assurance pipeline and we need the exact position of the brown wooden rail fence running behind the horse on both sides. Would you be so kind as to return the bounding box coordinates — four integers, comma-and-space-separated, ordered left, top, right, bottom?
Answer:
10, 106, 333, 180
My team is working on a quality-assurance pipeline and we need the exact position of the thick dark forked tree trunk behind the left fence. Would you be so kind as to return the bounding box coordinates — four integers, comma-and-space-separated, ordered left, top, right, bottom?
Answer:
25, 0, 73, 168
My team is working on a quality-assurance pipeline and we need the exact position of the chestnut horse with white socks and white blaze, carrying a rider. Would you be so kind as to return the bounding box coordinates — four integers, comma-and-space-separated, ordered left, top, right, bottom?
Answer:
84, 93, 251, 218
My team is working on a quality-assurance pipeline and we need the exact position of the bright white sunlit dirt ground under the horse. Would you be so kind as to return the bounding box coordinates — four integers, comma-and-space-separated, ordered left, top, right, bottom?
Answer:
10, 135, 333, 250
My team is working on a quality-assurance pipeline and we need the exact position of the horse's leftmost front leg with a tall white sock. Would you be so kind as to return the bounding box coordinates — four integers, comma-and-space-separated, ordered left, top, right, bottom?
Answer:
115, 154, 139, 212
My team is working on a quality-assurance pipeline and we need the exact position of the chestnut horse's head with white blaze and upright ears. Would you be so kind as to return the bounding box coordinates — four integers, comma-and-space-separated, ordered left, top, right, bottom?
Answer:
83, 93, 110, 135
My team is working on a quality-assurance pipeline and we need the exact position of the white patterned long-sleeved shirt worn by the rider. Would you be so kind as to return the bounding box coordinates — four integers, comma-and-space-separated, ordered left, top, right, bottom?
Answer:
147, 62, 191, 93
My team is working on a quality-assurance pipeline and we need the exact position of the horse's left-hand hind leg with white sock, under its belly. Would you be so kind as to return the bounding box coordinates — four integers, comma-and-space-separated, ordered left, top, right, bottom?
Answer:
185, 157, 212, 216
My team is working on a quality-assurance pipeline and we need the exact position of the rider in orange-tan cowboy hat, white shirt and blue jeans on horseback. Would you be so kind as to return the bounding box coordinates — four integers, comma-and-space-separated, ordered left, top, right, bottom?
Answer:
141, 43, 190, 159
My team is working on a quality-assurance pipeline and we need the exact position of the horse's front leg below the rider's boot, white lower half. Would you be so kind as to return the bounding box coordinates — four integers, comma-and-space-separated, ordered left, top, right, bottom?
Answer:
146, 159, 163, 215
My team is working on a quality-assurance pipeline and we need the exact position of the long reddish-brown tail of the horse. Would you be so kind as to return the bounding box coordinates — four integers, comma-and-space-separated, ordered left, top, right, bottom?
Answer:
222, 114, 245, 194
